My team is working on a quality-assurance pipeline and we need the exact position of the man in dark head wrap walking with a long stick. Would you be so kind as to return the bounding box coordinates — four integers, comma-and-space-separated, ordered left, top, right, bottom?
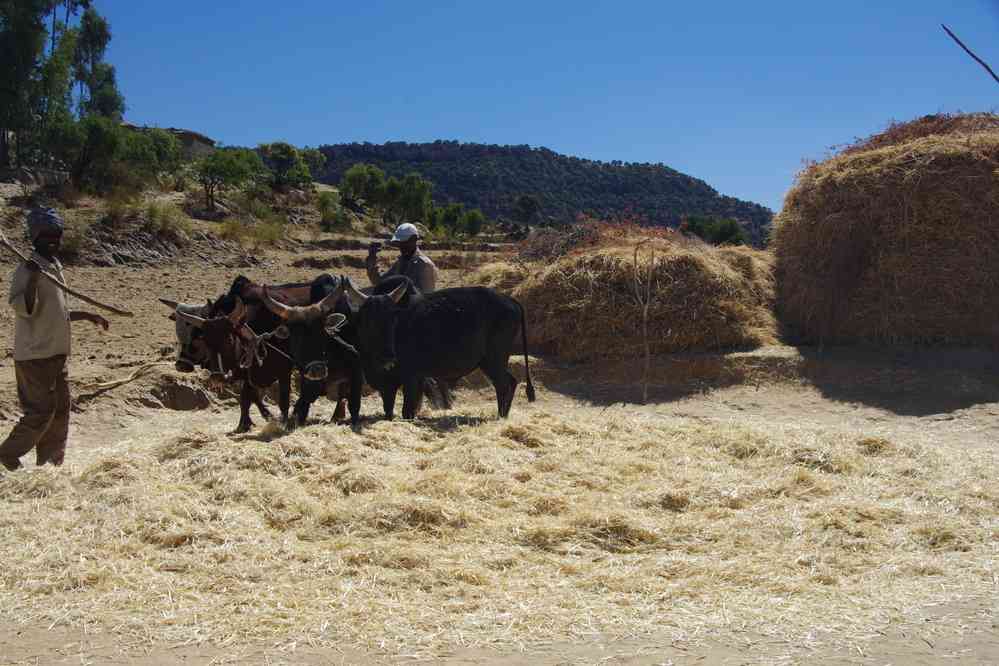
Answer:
0, 208, 108, 471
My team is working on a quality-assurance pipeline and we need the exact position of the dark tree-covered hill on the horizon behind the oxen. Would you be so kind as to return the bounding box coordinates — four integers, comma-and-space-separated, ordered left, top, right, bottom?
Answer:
316, 141, 773, 244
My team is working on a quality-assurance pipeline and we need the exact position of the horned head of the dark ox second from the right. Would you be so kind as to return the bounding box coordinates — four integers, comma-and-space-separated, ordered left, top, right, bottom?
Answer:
261, 281, 347, 381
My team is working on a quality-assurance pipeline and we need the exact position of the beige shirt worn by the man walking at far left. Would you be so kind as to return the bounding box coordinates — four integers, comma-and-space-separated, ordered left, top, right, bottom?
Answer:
7, 252, 70, 361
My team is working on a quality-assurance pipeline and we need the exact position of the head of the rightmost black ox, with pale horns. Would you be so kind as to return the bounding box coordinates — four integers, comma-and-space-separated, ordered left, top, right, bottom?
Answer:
342, 277, 415, 370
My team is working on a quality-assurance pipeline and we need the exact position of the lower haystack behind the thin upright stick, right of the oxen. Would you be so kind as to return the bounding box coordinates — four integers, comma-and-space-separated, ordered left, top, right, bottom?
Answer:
471, 231, 776, 361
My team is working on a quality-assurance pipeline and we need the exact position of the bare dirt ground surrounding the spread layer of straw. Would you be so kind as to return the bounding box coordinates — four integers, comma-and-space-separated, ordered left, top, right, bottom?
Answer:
0, 205, 999, 666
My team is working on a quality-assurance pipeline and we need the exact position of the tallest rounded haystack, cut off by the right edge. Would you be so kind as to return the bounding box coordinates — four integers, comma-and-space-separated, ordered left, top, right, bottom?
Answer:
774, 114, 999, 344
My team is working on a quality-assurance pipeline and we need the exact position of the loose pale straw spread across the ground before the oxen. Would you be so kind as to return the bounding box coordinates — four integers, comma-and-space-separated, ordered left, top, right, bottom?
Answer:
0, 391, 999, 658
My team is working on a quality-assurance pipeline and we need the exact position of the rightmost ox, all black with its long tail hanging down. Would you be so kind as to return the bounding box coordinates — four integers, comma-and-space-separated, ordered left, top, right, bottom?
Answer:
341, 277, 535, 419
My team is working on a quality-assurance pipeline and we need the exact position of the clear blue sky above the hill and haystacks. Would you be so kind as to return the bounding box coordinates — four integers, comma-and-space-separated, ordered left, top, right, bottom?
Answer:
96, 0, 999, 210
